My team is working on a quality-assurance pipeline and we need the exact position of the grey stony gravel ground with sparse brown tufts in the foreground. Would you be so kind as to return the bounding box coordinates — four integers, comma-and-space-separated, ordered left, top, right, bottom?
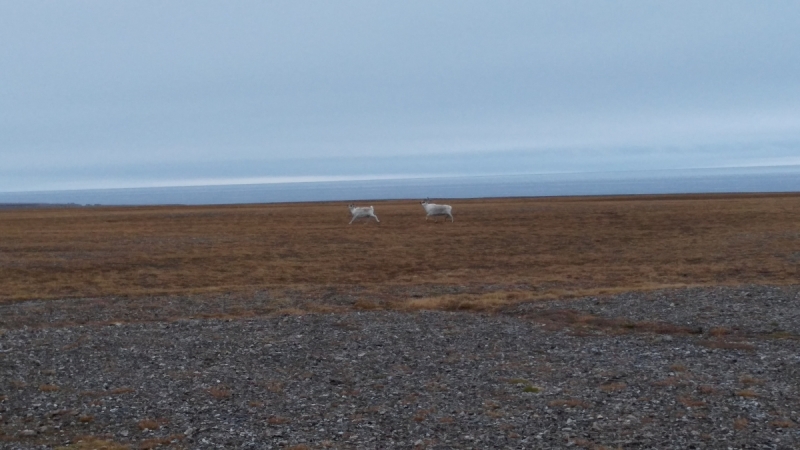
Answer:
0, 286, 800, 449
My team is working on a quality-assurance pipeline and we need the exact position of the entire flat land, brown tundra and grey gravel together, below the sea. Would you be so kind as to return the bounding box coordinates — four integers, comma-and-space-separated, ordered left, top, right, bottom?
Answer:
0, 194, 800, 450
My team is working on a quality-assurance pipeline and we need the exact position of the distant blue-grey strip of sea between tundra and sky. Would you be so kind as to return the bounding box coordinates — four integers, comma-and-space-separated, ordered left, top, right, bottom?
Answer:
0, 166, 800, 205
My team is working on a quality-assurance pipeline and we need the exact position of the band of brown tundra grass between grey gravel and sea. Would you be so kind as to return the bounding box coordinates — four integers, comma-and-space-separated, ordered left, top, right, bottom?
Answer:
0, 194, 800, 315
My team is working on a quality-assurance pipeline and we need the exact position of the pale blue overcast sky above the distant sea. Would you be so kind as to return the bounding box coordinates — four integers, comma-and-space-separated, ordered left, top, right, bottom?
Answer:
0, 0, 800, 191
